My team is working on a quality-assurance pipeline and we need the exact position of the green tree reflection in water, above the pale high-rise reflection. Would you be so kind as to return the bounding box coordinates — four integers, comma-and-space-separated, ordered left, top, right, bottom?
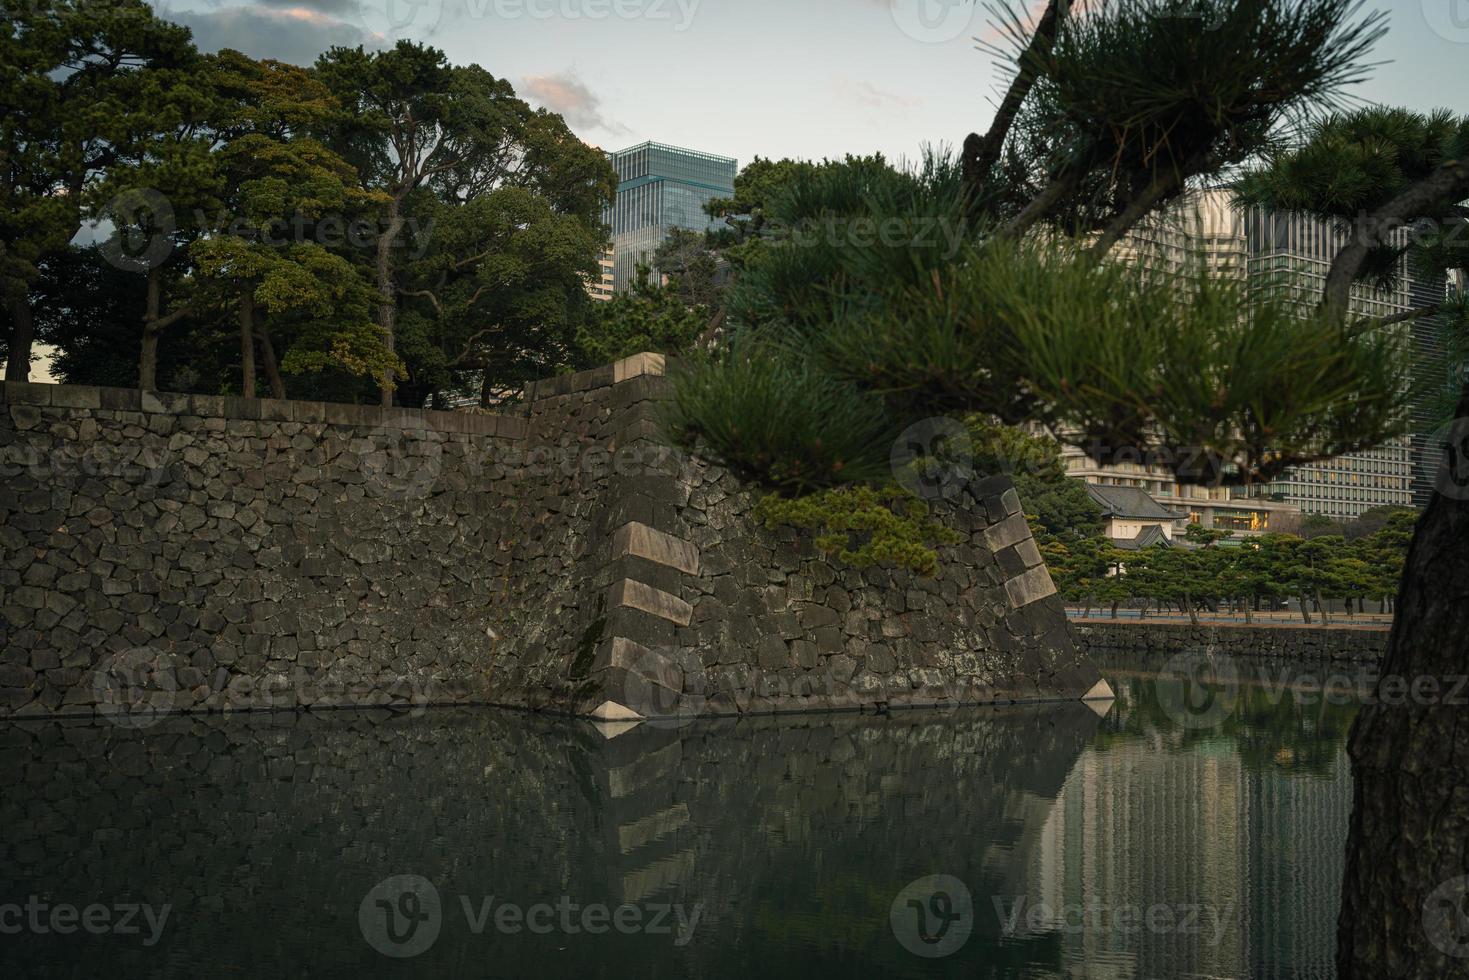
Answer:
1091, 661, 1362, 779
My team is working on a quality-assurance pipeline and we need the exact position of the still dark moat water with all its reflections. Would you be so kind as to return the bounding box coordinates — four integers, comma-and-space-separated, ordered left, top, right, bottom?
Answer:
0, 663, 1356, 980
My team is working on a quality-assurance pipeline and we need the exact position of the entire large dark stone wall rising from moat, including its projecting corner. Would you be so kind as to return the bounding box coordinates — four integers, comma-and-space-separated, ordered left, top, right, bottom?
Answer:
0, 354, 1108, 720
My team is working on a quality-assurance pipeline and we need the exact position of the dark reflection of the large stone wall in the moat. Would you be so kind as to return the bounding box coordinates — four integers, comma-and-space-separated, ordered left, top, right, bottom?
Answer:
0, 705, 1097, 977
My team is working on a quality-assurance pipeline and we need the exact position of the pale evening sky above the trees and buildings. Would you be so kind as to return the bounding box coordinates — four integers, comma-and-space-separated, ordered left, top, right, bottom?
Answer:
154, 0, 1469, 163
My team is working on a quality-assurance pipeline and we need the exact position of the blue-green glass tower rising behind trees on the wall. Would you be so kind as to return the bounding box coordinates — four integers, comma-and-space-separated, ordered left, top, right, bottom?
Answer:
604, 143, 737, 292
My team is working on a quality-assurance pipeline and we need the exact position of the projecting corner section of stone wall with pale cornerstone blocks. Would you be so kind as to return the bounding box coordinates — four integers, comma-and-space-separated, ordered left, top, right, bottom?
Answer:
552, 356, 1105, 721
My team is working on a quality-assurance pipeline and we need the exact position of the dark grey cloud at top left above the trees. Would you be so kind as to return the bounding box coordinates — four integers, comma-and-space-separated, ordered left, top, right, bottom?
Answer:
169, 0, 380, 65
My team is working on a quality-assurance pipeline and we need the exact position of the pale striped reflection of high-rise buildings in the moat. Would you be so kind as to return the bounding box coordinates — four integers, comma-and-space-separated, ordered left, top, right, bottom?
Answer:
1034, 705, 1351, 977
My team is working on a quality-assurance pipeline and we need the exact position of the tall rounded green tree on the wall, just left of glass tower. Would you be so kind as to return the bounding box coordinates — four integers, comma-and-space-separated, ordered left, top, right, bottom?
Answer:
316, 41, 616, 404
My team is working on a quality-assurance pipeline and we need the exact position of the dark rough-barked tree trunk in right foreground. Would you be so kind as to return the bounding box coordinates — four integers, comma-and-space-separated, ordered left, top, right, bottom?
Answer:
1337, 389, 1469, 980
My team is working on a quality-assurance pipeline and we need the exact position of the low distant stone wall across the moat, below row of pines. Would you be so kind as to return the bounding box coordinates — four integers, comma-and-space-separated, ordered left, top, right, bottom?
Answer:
1071, 620, 1388, 664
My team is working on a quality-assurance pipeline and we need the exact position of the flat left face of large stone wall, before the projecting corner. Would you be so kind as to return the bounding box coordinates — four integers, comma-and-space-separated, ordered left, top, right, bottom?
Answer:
0, 385, 526, 716
